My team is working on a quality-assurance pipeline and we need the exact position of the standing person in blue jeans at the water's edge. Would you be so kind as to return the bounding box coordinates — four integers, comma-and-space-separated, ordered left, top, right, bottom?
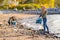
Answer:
39, 6, 49, 34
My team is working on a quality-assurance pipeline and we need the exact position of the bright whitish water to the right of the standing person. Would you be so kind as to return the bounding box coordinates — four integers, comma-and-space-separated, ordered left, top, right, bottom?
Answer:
47, 15, 60, 33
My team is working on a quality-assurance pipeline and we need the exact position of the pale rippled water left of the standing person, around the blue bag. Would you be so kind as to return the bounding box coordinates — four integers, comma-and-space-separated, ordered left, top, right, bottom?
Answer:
20, 16, 43, 30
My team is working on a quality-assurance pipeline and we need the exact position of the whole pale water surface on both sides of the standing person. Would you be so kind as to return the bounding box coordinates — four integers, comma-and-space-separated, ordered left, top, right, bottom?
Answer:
20, 14, 60, 35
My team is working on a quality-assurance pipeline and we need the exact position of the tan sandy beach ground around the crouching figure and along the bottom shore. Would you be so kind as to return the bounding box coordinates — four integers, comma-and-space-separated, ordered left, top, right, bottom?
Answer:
0, 14, 60, 40
